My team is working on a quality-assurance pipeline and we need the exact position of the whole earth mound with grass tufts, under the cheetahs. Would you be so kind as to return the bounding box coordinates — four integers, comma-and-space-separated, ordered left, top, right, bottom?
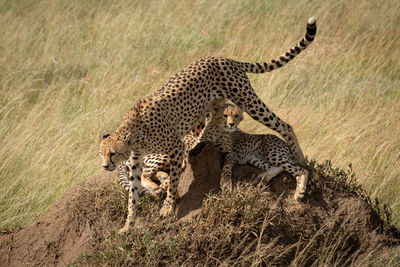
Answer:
0, 144, 400, 266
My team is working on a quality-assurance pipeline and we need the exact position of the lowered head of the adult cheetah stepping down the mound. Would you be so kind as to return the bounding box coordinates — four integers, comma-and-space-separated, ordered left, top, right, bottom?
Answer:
99, 132, 131, 171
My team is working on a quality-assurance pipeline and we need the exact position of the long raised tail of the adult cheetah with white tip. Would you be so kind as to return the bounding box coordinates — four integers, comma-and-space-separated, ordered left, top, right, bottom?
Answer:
238, 17, 317, 73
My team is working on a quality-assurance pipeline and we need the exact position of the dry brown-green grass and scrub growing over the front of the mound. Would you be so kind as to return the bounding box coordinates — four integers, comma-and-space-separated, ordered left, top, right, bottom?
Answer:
74, 161, 399, 266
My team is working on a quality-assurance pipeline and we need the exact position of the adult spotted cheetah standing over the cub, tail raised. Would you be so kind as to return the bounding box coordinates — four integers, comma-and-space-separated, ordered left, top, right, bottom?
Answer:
100, 17, 317, 232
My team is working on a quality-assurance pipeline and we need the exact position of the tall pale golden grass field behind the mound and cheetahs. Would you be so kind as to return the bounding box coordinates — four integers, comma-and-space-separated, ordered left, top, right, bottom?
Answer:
0, 0, 400, 228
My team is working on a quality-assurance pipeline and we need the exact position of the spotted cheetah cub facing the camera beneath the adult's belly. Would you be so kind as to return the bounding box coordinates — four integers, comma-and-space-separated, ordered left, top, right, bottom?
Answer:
200, 104, 308, 200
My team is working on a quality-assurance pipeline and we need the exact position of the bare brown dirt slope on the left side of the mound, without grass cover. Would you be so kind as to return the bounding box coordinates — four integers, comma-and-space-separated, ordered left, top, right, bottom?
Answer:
0, 174, 114, 266
